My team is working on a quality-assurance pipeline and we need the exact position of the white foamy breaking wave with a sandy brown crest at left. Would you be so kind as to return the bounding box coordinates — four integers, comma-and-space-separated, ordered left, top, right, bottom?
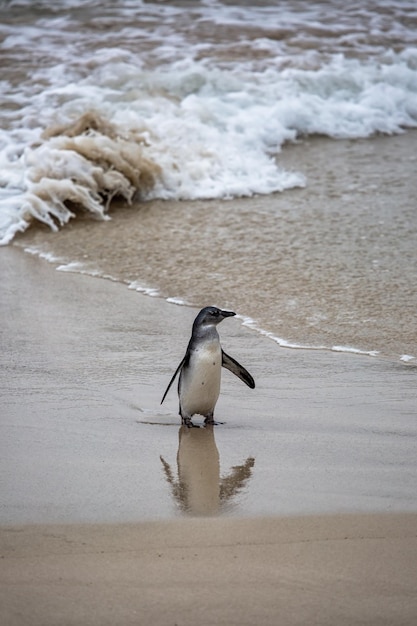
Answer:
0, 2, 417, 244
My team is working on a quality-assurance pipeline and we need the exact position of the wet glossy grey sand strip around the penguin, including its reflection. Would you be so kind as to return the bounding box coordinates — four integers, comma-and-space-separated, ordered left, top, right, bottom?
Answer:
0, 247, 417, 524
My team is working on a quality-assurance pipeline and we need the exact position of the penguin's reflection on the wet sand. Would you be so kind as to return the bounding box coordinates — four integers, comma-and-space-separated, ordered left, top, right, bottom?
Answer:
160, 426, 255, 515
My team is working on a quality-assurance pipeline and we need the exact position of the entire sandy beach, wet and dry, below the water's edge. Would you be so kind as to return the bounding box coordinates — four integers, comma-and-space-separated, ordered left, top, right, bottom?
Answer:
0, 246, 417, 626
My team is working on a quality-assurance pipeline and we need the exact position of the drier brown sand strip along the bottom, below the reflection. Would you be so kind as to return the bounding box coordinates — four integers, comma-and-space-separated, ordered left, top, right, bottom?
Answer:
0, 515, 417, 626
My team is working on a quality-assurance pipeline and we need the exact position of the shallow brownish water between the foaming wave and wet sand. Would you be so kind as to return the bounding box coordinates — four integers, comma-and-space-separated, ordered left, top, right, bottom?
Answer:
16, 133, 417, 363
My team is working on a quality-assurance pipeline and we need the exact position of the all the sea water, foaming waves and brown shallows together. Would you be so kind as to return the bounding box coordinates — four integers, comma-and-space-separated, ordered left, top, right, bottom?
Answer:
0, 0, 417, 356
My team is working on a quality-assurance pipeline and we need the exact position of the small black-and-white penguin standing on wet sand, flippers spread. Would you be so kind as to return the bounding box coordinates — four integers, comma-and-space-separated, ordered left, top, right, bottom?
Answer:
161, 306, 255, 428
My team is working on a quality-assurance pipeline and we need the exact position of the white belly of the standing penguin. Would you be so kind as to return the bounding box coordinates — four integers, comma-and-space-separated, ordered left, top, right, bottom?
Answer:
180, 341, 222, 417
